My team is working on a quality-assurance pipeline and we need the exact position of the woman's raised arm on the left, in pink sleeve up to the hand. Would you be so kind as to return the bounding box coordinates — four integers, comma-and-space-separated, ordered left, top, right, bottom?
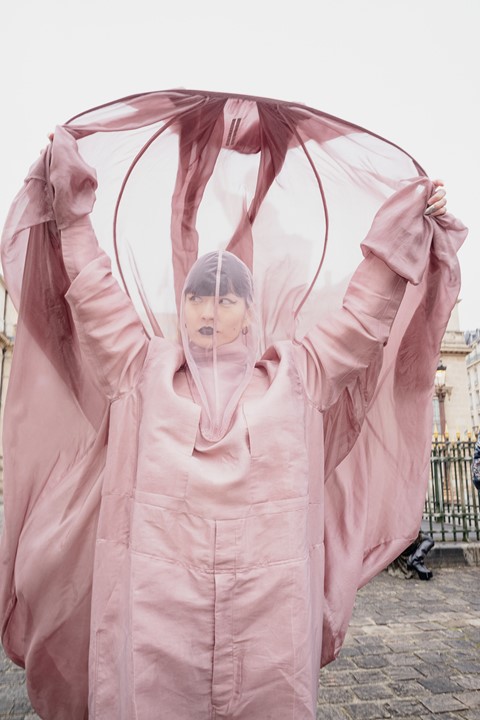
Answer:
50, 128, 148, 398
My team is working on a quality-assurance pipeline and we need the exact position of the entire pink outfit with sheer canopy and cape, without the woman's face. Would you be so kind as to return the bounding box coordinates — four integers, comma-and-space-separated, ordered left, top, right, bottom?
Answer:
0, 90, 466, 720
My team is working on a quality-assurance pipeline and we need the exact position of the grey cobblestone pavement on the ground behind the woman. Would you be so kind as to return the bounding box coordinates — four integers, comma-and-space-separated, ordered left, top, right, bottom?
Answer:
0, 565, 480, 720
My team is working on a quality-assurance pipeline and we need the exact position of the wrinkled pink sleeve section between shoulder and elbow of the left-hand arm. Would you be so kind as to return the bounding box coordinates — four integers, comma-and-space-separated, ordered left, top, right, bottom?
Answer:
65, 249, 148, 398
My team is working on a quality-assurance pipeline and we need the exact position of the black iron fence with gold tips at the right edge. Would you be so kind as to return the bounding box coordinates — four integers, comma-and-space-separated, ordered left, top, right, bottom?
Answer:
422, 437, 480, 542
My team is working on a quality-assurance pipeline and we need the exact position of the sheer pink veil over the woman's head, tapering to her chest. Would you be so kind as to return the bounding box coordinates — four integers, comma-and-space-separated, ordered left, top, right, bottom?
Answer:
180, 252, 259, 441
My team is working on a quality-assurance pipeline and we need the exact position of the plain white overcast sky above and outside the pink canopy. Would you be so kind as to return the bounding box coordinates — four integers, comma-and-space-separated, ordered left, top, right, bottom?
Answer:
0, 0, 480, 329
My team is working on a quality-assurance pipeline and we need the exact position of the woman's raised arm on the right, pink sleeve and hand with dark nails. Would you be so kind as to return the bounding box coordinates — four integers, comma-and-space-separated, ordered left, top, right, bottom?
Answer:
296, 178, 445, 411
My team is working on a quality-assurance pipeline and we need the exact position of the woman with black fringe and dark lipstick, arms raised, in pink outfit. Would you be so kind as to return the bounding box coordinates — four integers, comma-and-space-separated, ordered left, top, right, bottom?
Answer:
3, 91, 463, 720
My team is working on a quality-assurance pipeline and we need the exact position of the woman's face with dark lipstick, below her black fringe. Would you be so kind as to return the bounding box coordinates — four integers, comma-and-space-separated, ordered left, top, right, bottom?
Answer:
184, 292, 248, 348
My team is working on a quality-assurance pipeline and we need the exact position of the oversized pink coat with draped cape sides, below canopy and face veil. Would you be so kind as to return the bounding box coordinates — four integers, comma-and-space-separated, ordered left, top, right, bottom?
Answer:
1, 93, 465, 720
